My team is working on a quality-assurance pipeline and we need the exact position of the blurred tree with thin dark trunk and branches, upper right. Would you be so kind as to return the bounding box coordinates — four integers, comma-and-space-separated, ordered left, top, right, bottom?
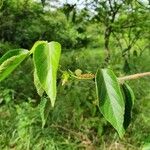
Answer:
82, 0, 150, 66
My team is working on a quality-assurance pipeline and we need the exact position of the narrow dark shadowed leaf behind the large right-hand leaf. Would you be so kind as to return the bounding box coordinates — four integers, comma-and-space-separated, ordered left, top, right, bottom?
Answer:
122, 83, 135, 129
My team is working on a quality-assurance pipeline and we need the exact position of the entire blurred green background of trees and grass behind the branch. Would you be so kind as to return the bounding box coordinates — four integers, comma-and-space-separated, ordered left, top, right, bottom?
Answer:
0, 0, 150, 150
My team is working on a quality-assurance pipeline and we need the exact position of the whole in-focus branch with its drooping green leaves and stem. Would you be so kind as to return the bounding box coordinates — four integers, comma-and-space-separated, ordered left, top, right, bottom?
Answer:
0, 41, 150, 138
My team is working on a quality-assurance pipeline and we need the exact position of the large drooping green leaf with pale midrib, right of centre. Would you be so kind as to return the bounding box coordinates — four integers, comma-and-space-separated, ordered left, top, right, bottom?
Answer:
96, 69, 125, 138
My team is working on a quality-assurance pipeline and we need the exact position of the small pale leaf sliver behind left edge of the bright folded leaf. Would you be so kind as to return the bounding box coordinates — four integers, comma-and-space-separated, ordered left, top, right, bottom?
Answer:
34, 70, 44, 96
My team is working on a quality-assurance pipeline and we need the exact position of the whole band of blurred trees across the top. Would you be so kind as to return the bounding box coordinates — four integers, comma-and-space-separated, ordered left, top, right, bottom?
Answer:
0, 0, 149, 58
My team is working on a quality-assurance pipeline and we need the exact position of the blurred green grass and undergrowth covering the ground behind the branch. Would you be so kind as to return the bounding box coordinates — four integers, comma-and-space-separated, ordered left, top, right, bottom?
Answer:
0, 48, 150, 150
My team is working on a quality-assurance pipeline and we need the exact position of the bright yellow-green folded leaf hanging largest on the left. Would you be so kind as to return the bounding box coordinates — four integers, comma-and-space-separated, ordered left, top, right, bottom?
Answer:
33, 42, 61, 106
